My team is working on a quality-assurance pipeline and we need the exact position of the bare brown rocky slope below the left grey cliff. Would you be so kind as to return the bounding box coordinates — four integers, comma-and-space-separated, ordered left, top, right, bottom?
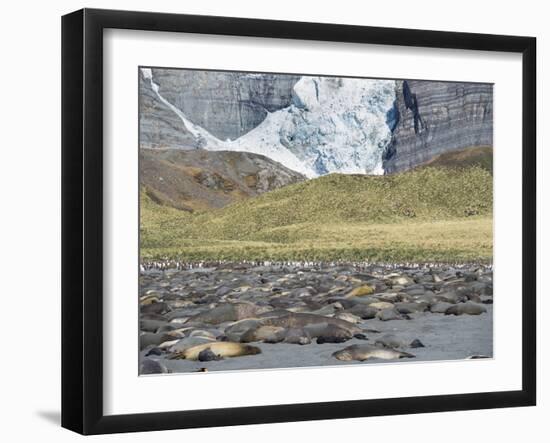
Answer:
140, 148, 304, 211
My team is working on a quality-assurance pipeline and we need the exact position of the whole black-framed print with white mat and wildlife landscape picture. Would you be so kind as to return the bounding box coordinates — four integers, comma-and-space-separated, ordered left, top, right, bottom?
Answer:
62, 9, 536, 434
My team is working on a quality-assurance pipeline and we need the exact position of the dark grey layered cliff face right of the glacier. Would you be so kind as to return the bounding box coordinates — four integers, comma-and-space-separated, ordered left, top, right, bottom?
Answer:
384, 80, 493, 173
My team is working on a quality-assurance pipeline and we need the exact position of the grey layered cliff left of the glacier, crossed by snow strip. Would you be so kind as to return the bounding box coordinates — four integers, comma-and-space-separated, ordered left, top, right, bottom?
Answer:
140, 68, 300, 149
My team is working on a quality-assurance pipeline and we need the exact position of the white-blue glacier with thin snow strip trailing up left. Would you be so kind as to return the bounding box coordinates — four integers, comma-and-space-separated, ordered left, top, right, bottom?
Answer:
142, 68, 396, 178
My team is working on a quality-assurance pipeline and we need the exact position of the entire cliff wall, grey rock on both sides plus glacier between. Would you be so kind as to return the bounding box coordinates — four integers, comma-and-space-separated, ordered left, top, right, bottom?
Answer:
139, 68, 493, 178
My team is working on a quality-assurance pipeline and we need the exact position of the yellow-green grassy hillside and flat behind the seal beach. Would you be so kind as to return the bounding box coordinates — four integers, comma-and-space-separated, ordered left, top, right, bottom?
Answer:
141, 166, 493, 262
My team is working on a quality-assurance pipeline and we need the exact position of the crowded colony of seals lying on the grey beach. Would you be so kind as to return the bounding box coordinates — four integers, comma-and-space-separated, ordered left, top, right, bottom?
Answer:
139, 262, 493, 374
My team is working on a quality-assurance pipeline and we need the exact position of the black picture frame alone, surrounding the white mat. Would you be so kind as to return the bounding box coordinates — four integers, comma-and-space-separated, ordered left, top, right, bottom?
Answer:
62, 9, 536, 434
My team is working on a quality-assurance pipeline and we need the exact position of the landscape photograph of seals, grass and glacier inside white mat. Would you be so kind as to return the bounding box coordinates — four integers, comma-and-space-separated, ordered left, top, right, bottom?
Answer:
136, 66, 493, 375
